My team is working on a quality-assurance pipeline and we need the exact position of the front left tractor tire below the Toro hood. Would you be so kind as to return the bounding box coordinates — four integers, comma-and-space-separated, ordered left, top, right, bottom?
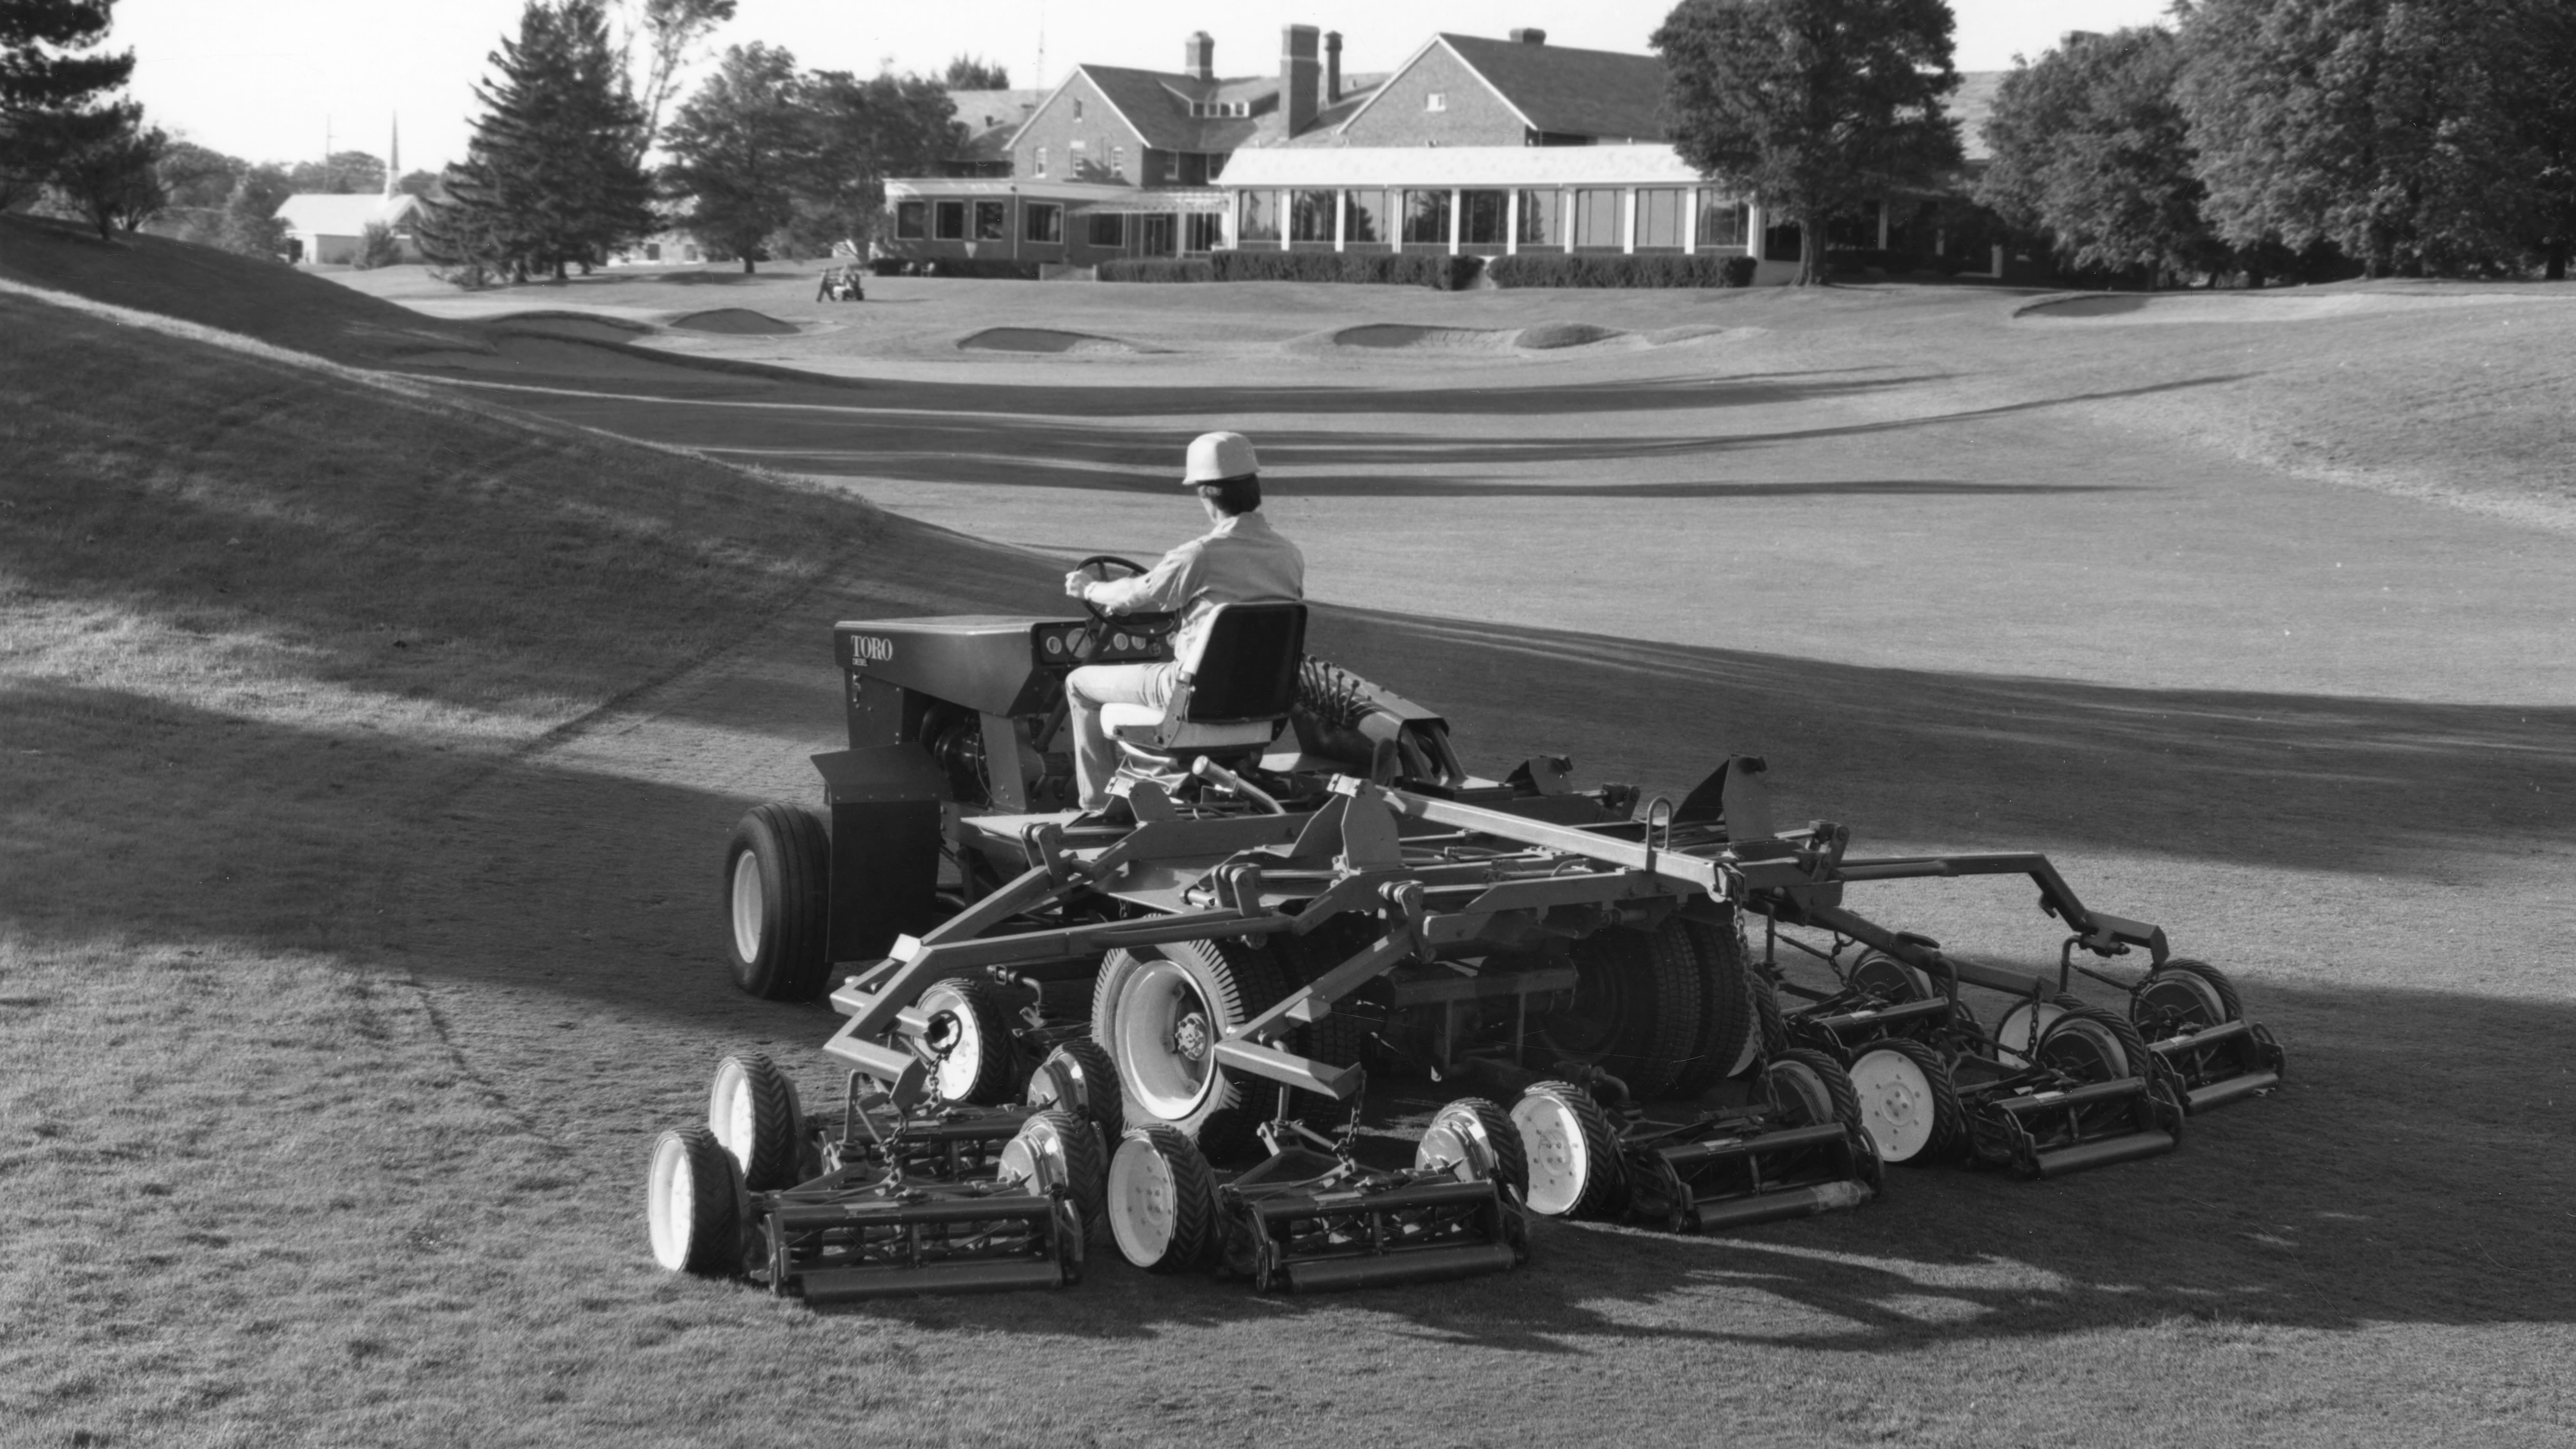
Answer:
724, 802, 832, 1000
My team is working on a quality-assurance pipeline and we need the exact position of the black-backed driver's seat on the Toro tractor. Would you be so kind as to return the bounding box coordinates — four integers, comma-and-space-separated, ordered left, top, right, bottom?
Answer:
1100, 603, 1306, 758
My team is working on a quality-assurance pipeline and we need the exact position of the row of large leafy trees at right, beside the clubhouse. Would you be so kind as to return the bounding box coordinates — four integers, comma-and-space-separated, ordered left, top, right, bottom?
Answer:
1654, 0, 2576, 286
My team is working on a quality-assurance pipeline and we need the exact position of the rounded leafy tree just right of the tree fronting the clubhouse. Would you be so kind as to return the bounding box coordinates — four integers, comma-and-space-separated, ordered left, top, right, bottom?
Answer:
1976, 28, 2226, 284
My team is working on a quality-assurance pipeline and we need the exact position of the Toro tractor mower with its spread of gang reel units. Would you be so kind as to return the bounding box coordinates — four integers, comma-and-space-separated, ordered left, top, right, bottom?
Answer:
652, 559, 2287, 1294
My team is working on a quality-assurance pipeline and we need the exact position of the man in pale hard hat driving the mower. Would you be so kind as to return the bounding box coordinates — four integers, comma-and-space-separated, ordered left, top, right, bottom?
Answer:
1064, 433, 1306, 810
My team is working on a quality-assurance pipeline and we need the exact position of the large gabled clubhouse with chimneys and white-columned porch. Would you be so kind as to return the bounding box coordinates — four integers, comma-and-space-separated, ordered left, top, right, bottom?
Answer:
876, 26, 2001, 284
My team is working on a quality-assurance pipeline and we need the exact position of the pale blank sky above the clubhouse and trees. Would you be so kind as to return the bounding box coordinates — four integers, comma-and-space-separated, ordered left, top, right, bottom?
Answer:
113, 0, 2167, 170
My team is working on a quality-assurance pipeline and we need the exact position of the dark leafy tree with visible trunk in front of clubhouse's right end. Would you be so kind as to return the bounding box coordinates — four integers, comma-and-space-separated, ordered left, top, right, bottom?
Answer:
1651, 0, 1960, 286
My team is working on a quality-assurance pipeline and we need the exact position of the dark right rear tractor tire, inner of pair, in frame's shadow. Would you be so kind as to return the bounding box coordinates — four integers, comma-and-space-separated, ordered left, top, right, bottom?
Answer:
1541, 926, 1700, 1101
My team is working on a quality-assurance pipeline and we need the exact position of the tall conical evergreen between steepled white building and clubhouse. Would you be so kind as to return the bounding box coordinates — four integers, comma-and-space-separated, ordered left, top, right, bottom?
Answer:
415, 0, 654, 278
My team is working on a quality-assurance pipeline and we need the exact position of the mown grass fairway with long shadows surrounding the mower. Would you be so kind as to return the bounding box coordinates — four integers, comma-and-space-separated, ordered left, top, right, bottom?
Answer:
0, 222, 2576, 1449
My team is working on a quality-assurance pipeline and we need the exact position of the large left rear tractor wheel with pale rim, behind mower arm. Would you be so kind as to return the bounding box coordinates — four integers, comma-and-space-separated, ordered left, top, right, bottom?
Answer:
1092, 938, 1288, 1160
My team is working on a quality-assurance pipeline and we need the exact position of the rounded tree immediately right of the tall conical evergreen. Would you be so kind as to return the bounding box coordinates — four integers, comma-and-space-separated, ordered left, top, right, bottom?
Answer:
662, 41, 814, 273
